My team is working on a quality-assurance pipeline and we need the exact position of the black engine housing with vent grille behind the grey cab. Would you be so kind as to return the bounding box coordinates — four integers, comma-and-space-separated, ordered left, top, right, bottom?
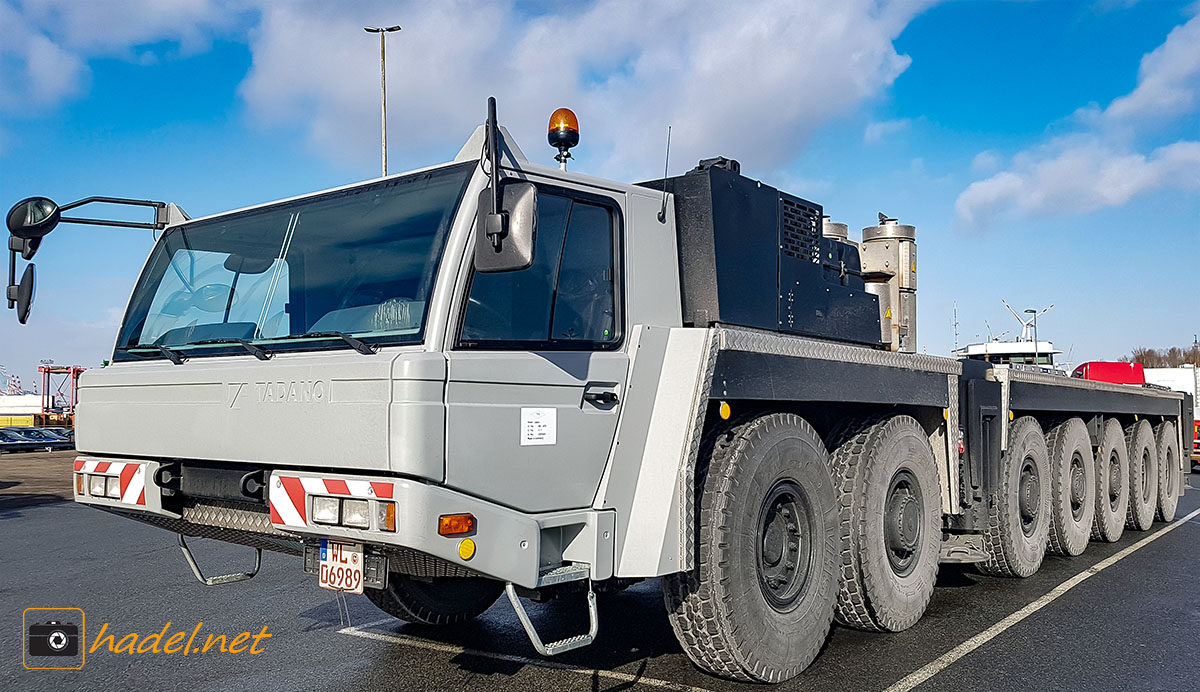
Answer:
640, 158, 881, 345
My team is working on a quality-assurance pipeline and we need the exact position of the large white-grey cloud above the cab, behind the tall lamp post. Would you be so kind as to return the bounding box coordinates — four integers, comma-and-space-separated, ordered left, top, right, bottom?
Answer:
242, 0, 928, 176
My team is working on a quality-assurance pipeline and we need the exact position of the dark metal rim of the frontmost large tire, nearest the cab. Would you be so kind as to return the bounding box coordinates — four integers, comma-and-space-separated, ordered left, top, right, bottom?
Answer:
755, 480, 812, 612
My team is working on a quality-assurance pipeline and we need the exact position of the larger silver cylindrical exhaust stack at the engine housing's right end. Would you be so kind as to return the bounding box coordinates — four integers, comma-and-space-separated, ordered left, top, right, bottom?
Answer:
860, 213, 917, 353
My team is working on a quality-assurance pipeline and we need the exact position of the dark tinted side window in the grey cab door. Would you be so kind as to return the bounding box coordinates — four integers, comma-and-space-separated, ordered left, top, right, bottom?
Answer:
460, 192, 618, 348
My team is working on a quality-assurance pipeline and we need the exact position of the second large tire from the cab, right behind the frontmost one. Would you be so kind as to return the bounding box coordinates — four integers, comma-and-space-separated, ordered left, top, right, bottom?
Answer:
830, 416, 942, 632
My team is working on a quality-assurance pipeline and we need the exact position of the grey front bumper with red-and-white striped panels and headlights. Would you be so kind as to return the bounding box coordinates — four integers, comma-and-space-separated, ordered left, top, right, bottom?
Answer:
74, 456, 616, 588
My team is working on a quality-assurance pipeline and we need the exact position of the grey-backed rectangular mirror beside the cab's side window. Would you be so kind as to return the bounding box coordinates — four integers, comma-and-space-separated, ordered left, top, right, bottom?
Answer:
475, 182, 538, 273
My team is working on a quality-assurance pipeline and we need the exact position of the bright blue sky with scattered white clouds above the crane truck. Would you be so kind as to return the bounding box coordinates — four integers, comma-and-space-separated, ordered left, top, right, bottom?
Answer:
0, 0, 1200, 384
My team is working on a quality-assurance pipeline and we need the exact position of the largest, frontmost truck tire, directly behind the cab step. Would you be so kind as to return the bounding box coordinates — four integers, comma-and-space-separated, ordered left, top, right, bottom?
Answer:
662, 414, 838, 682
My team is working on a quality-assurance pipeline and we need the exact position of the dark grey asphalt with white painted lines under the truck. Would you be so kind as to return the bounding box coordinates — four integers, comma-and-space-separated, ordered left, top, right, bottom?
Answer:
0, 458, 1200, 692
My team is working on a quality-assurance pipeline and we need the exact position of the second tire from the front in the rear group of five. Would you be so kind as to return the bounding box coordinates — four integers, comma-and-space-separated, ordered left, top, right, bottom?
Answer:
1046, 419, 1096, 555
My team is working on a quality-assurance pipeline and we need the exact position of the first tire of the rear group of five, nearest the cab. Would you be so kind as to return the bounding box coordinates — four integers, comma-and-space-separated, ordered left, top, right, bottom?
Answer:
979, 416, 1050, 577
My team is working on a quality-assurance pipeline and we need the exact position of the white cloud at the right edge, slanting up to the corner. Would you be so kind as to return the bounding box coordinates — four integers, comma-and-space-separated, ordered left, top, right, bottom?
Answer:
954, 10, 1200, 228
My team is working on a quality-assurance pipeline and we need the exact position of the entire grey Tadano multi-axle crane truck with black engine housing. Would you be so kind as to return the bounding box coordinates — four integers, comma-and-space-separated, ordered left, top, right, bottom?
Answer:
8, 98, 1192, 681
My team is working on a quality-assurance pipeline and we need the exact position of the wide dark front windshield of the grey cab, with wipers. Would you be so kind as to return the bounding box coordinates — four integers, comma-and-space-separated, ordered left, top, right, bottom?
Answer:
114, 163, 474, 360
